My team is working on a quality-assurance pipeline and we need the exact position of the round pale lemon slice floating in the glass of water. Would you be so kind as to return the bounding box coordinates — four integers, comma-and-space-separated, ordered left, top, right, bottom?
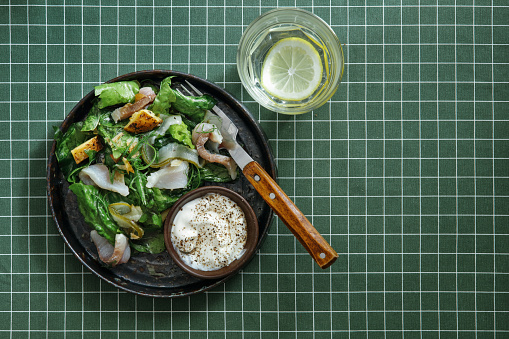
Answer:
261, 38, 323, 101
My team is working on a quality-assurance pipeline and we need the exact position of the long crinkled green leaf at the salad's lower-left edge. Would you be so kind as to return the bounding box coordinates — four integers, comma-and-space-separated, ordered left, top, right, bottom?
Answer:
69, 183, 120, 245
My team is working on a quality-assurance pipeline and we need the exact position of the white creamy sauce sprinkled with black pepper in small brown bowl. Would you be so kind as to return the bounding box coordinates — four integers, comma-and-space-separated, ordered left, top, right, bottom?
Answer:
171, 193, 247, 271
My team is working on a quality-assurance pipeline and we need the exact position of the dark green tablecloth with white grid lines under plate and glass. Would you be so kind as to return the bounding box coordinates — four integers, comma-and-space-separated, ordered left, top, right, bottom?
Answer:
0, 0, 509, 338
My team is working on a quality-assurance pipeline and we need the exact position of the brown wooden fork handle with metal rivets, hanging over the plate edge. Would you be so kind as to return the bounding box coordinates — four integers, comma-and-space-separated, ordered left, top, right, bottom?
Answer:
242, 161, 338, 268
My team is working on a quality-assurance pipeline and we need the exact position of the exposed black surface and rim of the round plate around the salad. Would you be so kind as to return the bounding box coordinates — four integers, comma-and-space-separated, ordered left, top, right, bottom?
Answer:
47, 70, 276, 297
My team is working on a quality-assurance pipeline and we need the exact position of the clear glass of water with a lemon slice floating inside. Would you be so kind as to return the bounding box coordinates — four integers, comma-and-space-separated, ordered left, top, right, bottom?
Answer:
237, 8, 344, 114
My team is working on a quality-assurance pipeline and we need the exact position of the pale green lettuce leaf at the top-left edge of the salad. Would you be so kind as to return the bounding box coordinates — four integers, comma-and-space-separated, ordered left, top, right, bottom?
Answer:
94, 81, 140, 108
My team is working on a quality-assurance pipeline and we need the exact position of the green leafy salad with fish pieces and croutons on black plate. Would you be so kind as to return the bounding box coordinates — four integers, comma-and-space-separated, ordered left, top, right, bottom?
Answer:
55, 77, 237, 266
